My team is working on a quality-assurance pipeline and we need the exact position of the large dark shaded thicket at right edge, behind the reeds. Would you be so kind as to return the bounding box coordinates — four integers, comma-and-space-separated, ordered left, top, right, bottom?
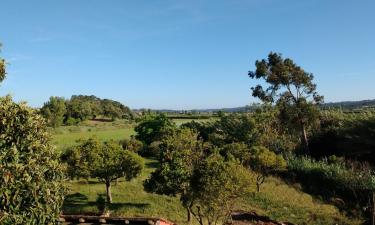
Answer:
310, 110, 375, 161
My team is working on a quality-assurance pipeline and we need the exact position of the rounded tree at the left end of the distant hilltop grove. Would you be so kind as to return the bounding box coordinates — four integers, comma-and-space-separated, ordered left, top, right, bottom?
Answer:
40, 97, 66, 127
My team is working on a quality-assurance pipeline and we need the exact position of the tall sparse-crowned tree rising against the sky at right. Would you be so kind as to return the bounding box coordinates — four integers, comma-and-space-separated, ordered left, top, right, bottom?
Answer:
248, 52, 323, 150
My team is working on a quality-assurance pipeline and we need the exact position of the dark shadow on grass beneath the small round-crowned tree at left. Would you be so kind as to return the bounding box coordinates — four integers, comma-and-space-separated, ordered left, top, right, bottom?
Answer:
63, 193, 150, 215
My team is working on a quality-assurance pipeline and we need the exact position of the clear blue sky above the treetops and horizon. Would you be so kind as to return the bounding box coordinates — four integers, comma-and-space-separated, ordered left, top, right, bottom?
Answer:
0, 0, 375, 109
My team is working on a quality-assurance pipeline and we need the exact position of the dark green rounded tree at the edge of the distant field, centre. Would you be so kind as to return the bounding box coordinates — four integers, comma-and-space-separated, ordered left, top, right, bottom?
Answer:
134, 114, 175, 145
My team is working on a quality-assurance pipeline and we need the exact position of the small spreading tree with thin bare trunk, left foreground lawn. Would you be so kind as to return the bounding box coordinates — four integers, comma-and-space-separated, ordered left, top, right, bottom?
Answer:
63, 138, 144, 203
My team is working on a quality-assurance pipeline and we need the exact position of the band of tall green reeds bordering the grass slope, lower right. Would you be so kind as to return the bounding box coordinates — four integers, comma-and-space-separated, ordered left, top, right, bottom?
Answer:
288, 157, 375, 219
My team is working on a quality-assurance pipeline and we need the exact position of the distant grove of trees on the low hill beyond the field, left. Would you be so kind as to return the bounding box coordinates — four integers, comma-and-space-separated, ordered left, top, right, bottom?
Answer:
40, 95, 134, 127
